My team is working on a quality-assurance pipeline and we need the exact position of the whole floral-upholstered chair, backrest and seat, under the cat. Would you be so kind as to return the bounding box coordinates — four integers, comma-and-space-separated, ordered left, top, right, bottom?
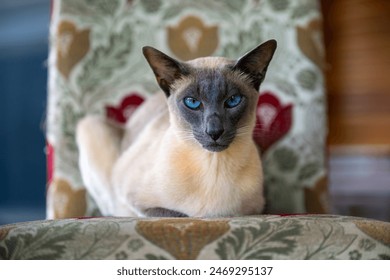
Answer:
0, 0, 390, 259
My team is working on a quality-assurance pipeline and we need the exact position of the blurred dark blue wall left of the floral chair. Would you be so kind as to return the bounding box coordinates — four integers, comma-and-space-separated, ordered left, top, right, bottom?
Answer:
0, 0, 50, 224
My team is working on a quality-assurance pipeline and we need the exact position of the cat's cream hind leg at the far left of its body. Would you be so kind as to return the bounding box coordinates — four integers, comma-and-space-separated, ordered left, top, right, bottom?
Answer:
76, 116, 122, 215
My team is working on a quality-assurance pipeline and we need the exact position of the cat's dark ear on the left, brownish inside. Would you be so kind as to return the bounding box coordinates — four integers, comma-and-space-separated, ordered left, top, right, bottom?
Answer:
142, 46, 188, 96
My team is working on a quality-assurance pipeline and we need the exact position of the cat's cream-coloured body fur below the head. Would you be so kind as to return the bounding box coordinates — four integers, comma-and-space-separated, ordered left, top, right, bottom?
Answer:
77, 94, 264, 217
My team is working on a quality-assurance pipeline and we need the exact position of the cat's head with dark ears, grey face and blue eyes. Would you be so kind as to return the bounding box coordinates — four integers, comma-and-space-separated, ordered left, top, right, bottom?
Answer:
143, 40, 276, 152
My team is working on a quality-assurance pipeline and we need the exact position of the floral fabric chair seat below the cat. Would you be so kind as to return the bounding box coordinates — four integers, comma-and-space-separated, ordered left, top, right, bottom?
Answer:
0, 215, 390, 260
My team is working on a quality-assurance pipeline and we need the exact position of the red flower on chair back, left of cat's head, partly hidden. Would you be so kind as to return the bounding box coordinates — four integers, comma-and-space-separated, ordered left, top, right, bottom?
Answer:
106, 93, 144, 124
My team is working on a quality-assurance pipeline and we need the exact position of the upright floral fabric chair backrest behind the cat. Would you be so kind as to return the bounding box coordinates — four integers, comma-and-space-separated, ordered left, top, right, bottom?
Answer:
47, 0, 326, 218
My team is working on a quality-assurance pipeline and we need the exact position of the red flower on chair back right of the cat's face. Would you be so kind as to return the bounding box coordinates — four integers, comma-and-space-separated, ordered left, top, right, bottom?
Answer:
253, 91, 293, 153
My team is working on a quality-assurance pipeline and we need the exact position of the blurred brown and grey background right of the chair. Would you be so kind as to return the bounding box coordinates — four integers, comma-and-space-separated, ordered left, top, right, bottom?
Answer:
322, 0, 390, 221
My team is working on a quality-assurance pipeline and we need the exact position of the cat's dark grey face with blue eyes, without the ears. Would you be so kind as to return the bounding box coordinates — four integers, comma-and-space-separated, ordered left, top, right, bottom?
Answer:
169, 58, 258, 152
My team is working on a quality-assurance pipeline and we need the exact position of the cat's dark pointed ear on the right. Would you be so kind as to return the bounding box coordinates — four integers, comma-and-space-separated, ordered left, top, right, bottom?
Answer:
233, 40, 277, 90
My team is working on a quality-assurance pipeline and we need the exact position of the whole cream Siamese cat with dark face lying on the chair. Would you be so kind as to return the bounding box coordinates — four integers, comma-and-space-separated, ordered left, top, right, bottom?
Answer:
76, 40, 276, 217
